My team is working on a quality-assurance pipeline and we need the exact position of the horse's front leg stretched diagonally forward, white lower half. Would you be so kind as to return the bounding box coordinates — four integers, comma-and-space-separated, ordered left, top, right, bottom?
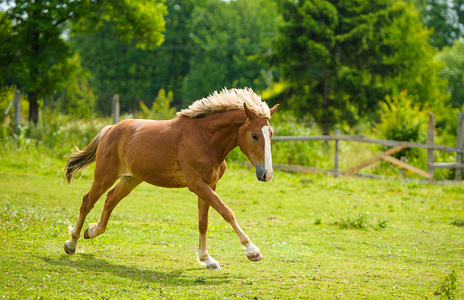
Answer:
189, 180, 263, 261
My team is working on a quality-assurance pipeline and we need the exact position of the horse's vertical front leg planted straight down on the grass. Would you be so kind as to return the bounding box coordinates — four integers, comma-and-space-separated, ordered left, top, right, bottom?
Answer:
198, 197, 221, 269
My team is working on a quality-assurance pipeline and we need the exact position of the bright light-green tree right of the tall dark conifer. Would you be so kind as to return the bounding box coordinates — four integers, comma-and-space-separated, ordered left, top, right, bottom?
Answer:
382, 1, 449, 112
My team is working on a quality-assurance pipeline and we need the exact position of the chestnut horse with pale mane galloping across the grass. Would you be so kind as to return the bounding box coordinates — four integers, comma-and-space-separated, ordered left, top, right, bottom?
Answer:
64, 88, 278, 269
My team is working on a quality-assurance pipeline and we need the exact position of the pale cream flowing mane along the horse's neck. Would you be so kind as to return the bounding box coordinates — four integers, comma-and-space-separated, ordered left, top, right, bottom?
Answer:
177, 88, 271, 119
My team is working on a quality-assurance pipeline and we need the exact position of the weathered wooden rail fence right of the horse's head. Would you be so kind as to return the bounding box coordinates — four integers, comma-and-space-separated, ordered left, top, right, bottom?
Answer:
272, 113, 464, 180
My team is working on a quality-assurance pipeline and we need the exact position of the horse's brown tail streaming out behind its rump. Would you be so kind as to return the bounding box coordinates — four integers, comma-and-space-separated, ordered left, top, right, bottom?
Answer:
64, 125, 112, 183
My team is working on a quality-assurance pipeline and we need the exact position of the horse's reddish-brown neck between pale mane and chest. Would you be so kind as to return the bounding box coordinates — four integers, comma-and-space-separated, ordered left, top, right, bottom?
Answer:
192, 110, 246, 163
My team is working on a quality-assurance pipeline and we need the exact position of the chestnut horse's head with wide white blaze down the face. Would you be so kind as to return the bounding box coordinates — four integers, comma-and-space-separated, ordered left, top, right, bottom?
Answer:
238, 103, 279, 181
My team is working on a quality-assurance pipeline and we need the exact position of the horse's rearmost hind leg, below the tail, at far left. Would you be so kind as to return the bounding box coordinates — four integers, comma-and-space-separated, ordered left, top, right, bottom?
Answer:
64, 178, 116, 254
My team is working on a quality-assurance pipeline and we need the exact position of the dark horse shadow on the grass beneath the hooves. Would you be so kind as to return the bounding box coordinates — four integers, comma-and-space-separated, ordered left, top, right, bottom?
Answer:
40, 254, 240, 286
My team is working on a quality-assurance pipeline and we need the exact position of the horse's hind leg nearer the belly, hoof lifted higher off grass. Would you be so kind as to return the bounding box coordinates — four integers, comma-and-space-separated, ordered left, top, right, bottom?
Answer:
84, 176, 142, 239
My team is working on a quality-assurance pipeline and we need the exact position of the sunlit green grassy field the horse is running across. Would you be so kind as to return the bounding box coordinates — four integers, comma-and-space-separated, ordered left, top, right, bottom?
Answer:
0, 155, 464, 299
